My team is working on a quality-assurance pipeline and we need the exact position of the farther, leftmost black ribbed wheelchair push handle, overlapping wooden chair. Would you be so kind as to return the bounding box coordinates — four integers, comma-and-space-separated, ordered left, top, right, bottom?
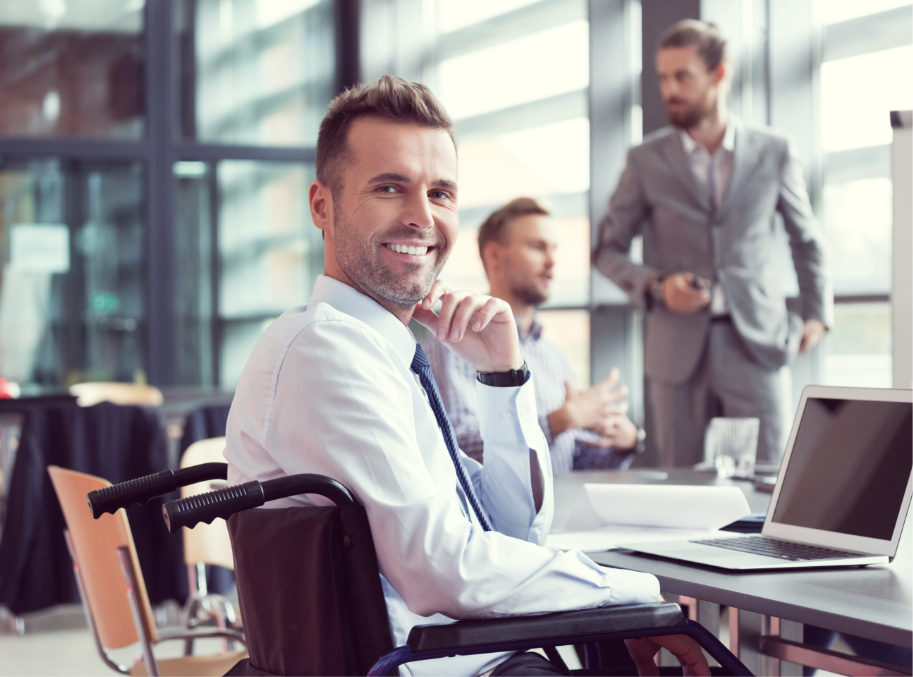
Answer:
86, 463, 228, 519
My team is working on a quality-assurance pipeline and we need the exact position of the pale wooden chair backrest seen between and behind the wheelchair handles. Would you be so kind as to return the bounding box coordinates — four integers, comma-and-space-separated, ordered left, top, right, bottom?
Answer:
181, 437, 235, 569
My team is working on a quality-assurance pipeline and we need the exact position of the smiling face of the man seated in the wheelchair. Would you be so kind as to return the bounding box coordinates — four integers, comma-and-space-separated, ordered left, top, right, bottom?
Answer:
324, 118, 459, 309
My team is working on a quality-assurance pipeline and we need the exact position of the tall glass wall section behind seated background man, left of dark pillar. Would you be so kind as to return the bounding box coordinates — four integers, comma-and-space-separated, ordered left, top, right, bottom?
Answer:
424, 0, 590, 383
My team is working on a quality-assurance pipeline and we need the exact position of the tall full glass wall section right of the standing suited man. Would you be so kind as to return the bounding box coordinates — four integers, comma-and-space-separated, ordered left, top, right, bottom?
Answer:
819, 0, 913, 387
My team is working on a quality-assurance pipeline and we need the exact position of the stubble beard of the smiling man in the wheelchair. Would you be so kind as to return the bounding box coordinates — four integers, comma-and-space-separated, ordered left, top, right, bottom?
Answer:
333, 212, 447, 308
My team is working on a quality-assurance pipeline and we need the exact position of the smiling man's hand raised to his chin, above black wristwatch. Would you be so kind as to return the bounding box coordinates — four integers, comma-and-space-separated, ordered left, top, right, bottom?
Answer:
412, 280, 523, 372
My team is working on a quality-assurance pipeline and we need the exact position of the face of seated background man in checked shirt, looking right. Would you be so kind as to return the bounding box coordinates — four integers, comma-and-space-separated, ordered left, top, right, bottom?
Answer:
492, 214, 558, 306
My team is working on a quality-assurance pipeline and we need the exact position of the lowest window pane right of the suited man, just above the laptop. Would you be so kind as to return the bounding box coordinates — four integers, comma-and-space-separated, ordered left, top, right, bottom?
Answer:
822, 303, 892, 388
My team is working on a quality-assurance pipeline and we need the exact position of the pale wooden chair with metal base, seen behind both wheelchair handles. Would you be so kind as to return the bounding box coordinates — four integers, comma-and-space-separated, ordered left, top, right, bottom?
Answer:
181, 437, 240, 653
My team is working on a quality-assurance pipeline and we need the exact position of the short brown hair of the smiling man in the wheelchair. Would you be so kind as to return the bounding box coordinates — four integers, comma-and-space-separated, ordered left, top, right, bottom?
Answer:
317, 75, 456, 195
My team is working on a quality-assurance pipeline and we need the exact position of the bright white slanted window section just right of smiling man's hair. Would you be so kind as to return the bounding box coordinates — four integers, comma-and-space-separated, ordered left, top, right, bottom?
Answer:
436, 20, 590, 120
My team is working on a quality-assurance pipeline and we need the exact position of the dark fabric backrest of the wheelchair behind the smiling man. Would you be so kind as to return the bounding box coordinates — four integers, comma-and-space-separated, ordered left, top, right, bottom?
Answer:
228, 505, 393, 677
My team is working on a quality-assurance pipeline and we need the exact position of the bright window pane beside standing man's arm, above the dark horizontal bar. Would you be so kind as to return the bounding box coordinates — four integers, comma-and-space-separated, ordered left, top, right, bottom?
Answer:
821, 178, 893, 294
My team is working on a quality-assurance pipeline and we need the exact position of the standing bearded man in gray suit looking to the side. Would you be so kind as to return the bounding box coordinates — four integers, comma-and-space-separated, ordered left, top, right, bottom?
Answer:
594, 20, 833, 466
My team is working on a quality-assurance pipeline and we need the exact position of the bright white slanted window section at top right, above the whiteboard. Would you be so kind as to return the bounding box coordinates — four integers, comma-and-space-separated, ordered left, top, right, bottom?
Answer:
821, 45, 913, 152
